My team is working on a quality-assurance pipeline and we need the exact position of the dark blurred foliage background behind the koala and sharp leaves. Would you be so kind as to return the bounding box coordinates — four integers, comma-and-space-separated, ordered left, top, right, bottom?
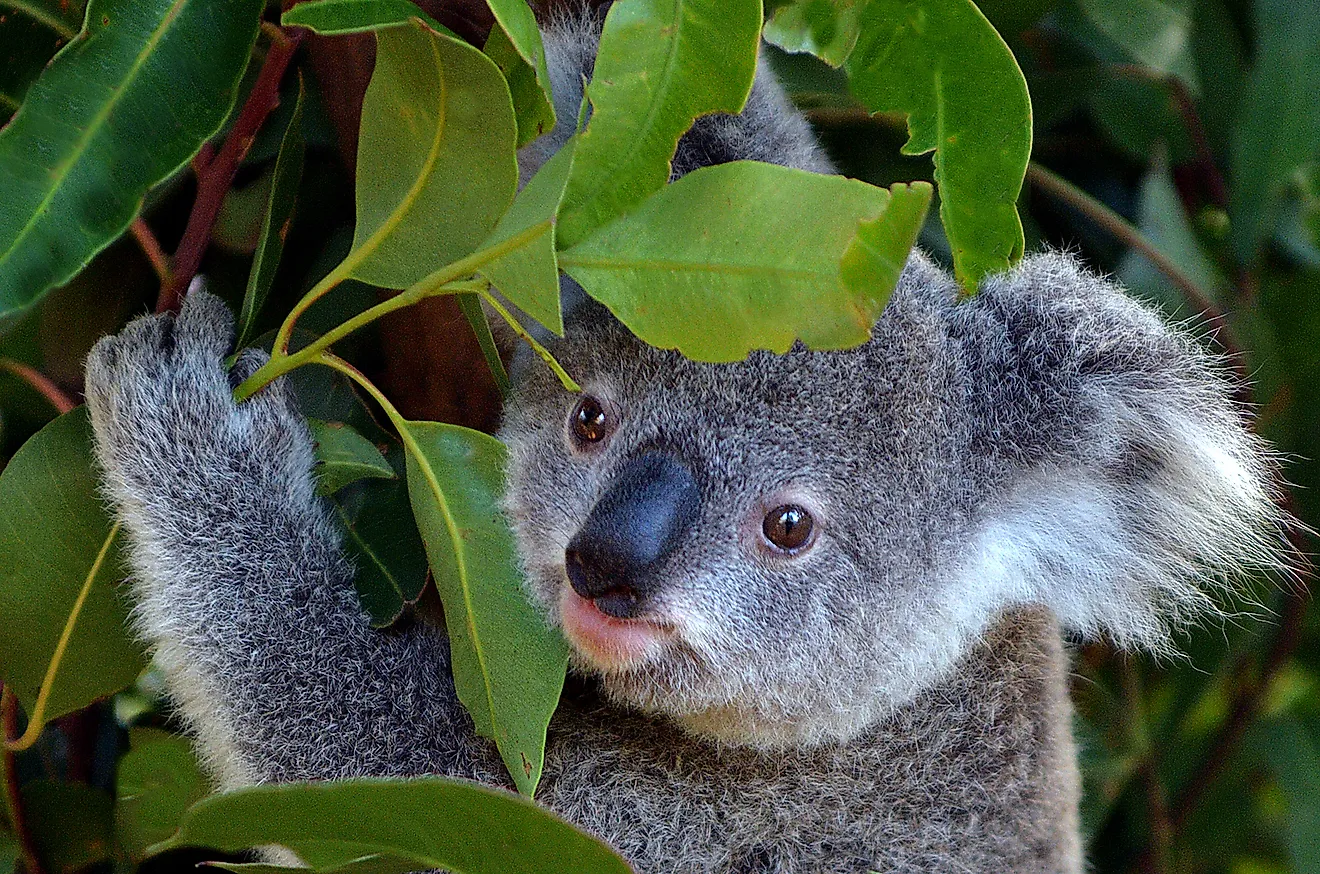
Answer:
0, 0, 1320, 874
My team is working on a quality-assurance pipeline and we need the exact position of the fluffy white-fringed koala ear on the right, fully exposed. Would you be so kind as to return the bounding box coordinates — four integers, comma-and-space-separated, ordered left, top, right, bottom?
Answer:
950, 253, 1295, 652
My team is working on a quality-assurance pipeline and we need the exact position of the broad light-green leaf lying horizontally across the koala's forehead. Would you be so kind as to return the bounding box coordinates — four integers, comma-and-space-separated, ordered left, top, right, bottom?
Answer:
560, 161, 931, 362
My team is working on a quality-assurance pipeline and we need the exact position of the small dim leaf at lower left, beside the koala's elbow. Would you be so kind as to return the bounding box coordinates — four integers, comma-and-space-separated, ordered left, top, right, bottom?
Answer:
115, 729, 209, 859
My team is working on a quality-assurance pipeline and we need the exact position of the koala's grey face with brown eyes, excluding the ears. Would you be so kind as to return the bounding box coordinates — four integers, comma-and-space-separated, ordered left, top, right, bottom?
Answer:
502, 270, 1003, 747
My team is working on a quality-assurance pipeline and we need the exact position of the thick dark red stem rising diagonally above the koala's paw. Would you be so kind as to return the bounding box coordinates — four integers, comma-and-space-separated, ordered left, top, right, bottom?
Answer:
156, 29, 305, 313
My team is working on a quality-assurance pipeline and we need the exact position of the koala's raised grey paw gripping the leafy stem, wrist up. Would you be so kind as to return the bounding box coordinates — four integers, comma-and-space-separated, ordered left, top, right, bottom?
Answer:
86, 290, 308, 491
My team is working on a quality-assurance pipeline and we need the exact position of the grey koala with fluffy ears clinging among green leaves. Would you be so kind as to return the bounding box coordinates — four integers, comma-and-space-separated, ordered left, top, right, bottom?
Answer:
87, 6, 1283, 874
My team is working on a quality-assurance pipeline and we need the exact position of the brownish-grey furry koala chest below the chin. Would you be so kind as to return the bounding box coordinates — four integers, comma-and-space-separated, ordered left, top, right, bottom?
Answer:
537, 612, 1080, 874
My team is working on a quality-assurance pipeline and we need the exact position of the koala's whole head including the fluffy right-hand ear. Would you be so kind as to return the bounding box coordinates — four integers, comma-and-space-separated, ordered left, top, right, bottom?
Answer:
502, 255, 1279, 747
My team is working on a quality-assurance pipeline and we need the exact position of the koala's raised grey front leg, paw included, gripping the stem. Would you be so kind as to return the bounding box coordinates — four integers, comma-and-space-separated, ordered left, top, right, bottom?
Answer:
87, 293, 488, 787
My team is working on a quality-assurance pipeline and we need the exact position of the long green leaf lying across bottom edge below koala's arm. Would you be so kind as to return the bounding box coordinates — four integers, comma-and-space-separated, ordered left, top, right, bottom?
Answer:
154, 778, 631, 874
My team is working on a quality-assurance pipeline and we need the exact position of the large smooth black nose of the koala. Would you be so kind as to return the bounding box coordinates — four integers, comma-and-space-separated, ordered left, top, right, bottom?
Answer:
564, 452, 701, 619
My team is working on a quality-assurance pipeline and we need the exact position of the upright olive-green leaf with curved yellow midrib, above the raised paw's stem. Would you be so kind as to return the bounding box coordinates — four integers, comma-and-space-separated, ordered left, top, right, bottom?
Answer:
334, 20, 517, 288
